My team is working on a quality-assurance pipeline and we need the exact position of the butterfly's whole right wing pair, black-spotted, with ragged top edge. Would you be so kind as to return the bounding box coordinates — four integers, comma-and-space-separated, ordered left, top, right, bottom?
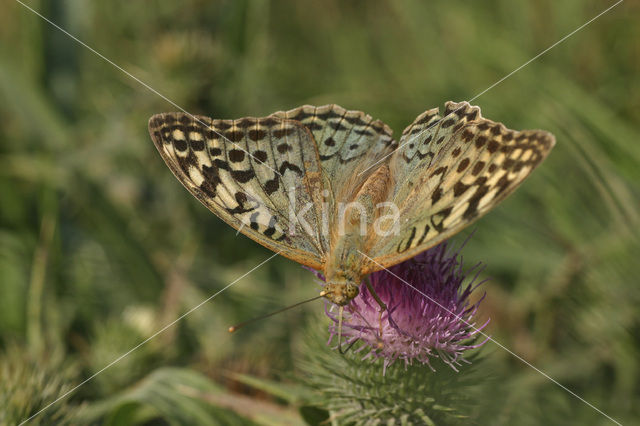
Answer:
369, 102, 555, 272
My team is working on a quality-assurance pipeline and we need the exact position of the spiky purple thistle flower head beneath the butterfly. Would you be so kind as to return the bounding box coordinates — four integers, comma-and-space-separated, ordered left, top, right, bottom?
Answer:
318, 243, 489, 371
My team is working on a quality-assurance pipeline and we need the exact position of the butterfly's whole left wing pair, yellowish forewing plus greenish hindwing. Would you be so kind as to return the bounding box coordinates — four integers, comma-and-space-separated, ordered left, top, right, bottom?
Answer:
149, 105, 397, 270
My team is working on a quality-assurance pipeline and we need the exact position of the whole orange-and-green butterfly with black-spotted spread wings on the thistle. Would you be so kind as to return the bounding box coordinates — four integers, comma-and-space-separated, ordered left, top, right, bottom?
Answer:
149, 102, 555, 306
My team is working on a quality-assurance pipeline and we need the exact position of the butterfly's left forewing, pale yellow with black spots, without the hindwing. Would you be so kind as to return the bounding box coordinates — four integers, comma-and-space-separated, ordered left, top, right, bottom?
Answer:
149, 113, 327, 269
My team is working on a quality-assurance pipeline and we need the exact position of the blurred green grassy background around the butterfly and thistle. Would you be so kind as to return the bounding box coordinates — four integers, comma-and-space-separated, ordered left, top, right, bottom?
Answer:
0, 0, 640, 424
